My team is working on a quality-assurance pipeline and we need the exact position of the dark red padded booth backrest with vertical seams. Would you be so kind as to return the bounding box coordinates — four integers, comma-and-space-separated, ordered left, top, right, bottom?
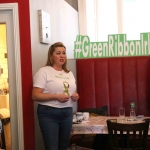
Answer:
76, 56, 150, 116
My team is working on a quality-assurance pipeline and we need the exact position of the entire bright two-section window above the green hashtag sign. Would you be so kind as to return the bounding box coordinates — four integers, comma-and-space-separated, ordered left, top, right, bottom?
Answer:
79, 0, 150, 42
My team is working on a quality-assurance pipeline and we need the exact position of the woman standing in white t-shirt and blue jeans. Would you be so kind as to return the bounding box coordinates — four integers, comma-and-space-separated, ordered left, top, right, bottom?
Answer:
32, 42, 79, 150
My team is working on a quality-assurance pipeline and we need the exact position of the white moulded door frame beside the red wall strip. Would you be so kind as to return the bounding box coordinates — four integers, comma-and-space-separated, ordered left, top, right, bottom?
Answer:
0, 3, 24, 150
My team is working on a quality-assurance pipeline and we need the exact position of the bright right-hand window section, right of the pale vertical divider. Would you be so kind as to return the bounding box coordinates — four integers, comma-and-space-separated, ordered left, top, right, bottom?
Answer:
122, 0, 150, 40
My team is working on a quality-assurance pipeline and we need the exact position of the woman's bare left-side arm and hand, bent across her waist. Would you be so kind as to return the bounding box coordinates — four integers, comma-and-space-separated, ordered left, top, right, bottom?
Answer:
32, 87, 69, 103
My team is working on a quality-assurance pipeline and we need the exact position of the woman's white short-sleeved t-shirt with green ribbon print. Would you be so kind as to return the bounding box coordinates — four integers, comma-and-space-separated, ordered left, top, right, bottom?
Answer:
33, 66, 76, 108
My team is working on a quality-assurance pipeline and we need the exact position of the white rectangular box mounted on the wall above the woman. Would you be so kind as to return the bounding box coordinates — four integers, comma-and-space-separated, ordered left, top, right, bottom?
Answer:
38, 10, 51, 44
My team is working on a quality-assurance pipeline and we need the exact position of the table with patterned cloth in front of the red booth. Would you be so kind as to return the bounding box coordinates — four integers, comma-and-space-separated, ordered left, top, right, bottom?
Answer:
71, 116, 150, 134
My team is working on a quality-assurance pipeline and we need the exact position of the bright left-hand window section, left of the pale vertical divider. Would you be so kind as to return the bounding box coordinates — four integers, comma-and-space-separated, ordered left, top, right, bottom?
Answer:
86, 0, 118, 42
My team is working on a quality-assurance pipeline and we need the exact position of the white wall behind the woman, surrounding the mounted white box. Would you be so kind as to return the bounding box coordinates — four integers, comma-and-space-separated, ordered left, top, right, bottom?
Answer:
29, 0, 78, 150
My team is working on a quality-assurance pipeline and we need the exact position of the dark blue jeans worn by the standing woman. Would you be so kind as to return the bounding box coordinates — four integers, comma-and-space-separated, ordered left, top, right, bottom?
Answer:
37, 104, 73, 150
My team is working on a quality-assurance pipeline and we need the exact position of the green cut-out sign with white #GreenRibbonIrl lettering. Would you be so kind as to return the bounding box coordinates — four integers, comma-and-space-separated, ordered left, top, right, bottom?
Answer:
74, 33, 150, 58
